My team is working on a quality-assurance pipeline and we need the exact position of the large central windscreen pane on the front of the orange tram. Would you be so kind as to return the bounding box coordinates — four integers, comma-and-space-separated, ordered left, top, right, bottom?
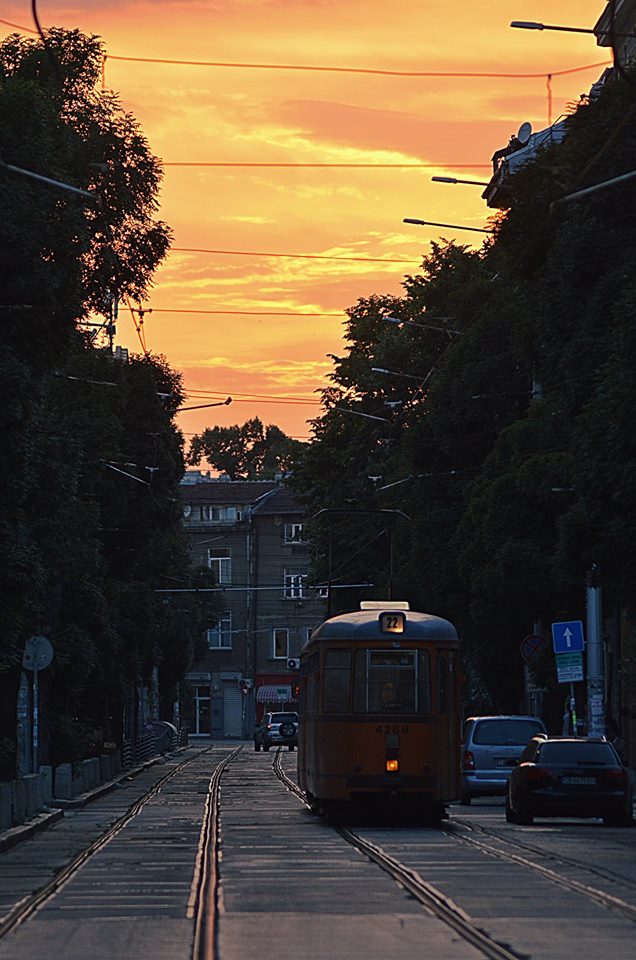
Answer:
354, 650, 418, 713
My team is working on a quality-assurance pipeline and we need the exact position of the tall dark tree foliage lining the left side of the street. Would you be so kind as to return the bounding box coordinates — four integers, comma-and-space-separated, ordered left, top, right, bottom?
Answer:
0, 29, 217, 778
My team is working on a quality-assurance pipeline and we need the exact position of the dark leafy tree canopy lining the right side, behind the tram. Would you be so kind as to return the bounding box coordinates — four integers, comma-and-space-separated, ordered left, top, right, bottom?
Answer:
291, 71, 636, 709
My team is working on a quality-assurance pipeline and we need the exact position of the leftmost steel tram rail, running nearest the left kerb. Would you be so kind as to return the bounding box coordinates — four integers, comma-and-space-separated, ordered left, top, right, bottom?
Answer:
0, 747, 212, 939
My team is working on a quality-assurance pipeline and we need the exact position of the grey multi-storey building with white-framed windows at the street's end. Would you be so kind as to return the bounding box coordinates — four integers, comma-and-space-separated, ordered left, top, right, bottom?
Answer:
181, 472, 326, 739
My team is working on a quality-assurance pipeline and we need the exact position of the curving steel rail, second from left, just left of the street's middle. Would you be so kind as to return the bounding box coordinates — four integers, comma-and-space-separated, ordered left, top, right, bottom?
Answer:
186, 745, 243, 960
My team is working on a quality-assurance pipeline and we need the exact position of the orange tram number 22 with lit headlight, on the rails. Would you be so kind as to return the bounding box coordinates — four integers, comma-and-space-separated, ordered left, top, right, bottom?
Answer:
298, 600, 460, 824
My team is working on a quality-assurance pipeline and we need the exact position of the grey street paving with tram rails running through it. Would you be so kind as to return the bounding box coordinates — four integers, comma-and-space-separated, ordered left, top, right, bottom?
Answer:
0, 743, 636, 960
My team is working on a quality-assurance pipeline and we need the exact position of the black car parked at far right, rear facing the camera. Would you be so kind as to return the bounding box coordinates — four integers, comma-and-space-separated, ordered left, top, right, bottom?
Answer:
506, 737, 632, 827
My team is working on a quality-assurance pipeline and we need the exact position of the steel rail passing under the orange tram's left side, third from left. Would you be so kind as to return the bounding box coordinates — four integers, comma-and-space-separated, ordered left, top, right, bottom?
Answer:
273, 747, 522, 960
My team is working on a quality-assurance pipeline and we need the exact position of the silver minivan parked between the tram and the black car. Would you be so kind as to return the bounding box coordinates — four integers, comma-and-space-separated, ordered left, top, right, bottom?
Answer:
459, 716, 546, 805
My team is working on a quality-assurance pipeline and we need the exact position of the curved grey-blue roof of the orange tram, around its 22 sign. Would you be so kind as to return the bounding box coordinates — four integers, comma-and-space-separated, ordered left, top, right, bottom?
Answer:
308, 602, 458, 643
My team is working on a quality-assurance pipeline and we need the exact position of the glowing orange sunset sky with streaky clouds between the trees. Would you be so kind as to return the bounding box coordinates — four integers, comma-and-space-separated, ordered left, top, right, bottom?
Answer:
0, 0, 610, 446
